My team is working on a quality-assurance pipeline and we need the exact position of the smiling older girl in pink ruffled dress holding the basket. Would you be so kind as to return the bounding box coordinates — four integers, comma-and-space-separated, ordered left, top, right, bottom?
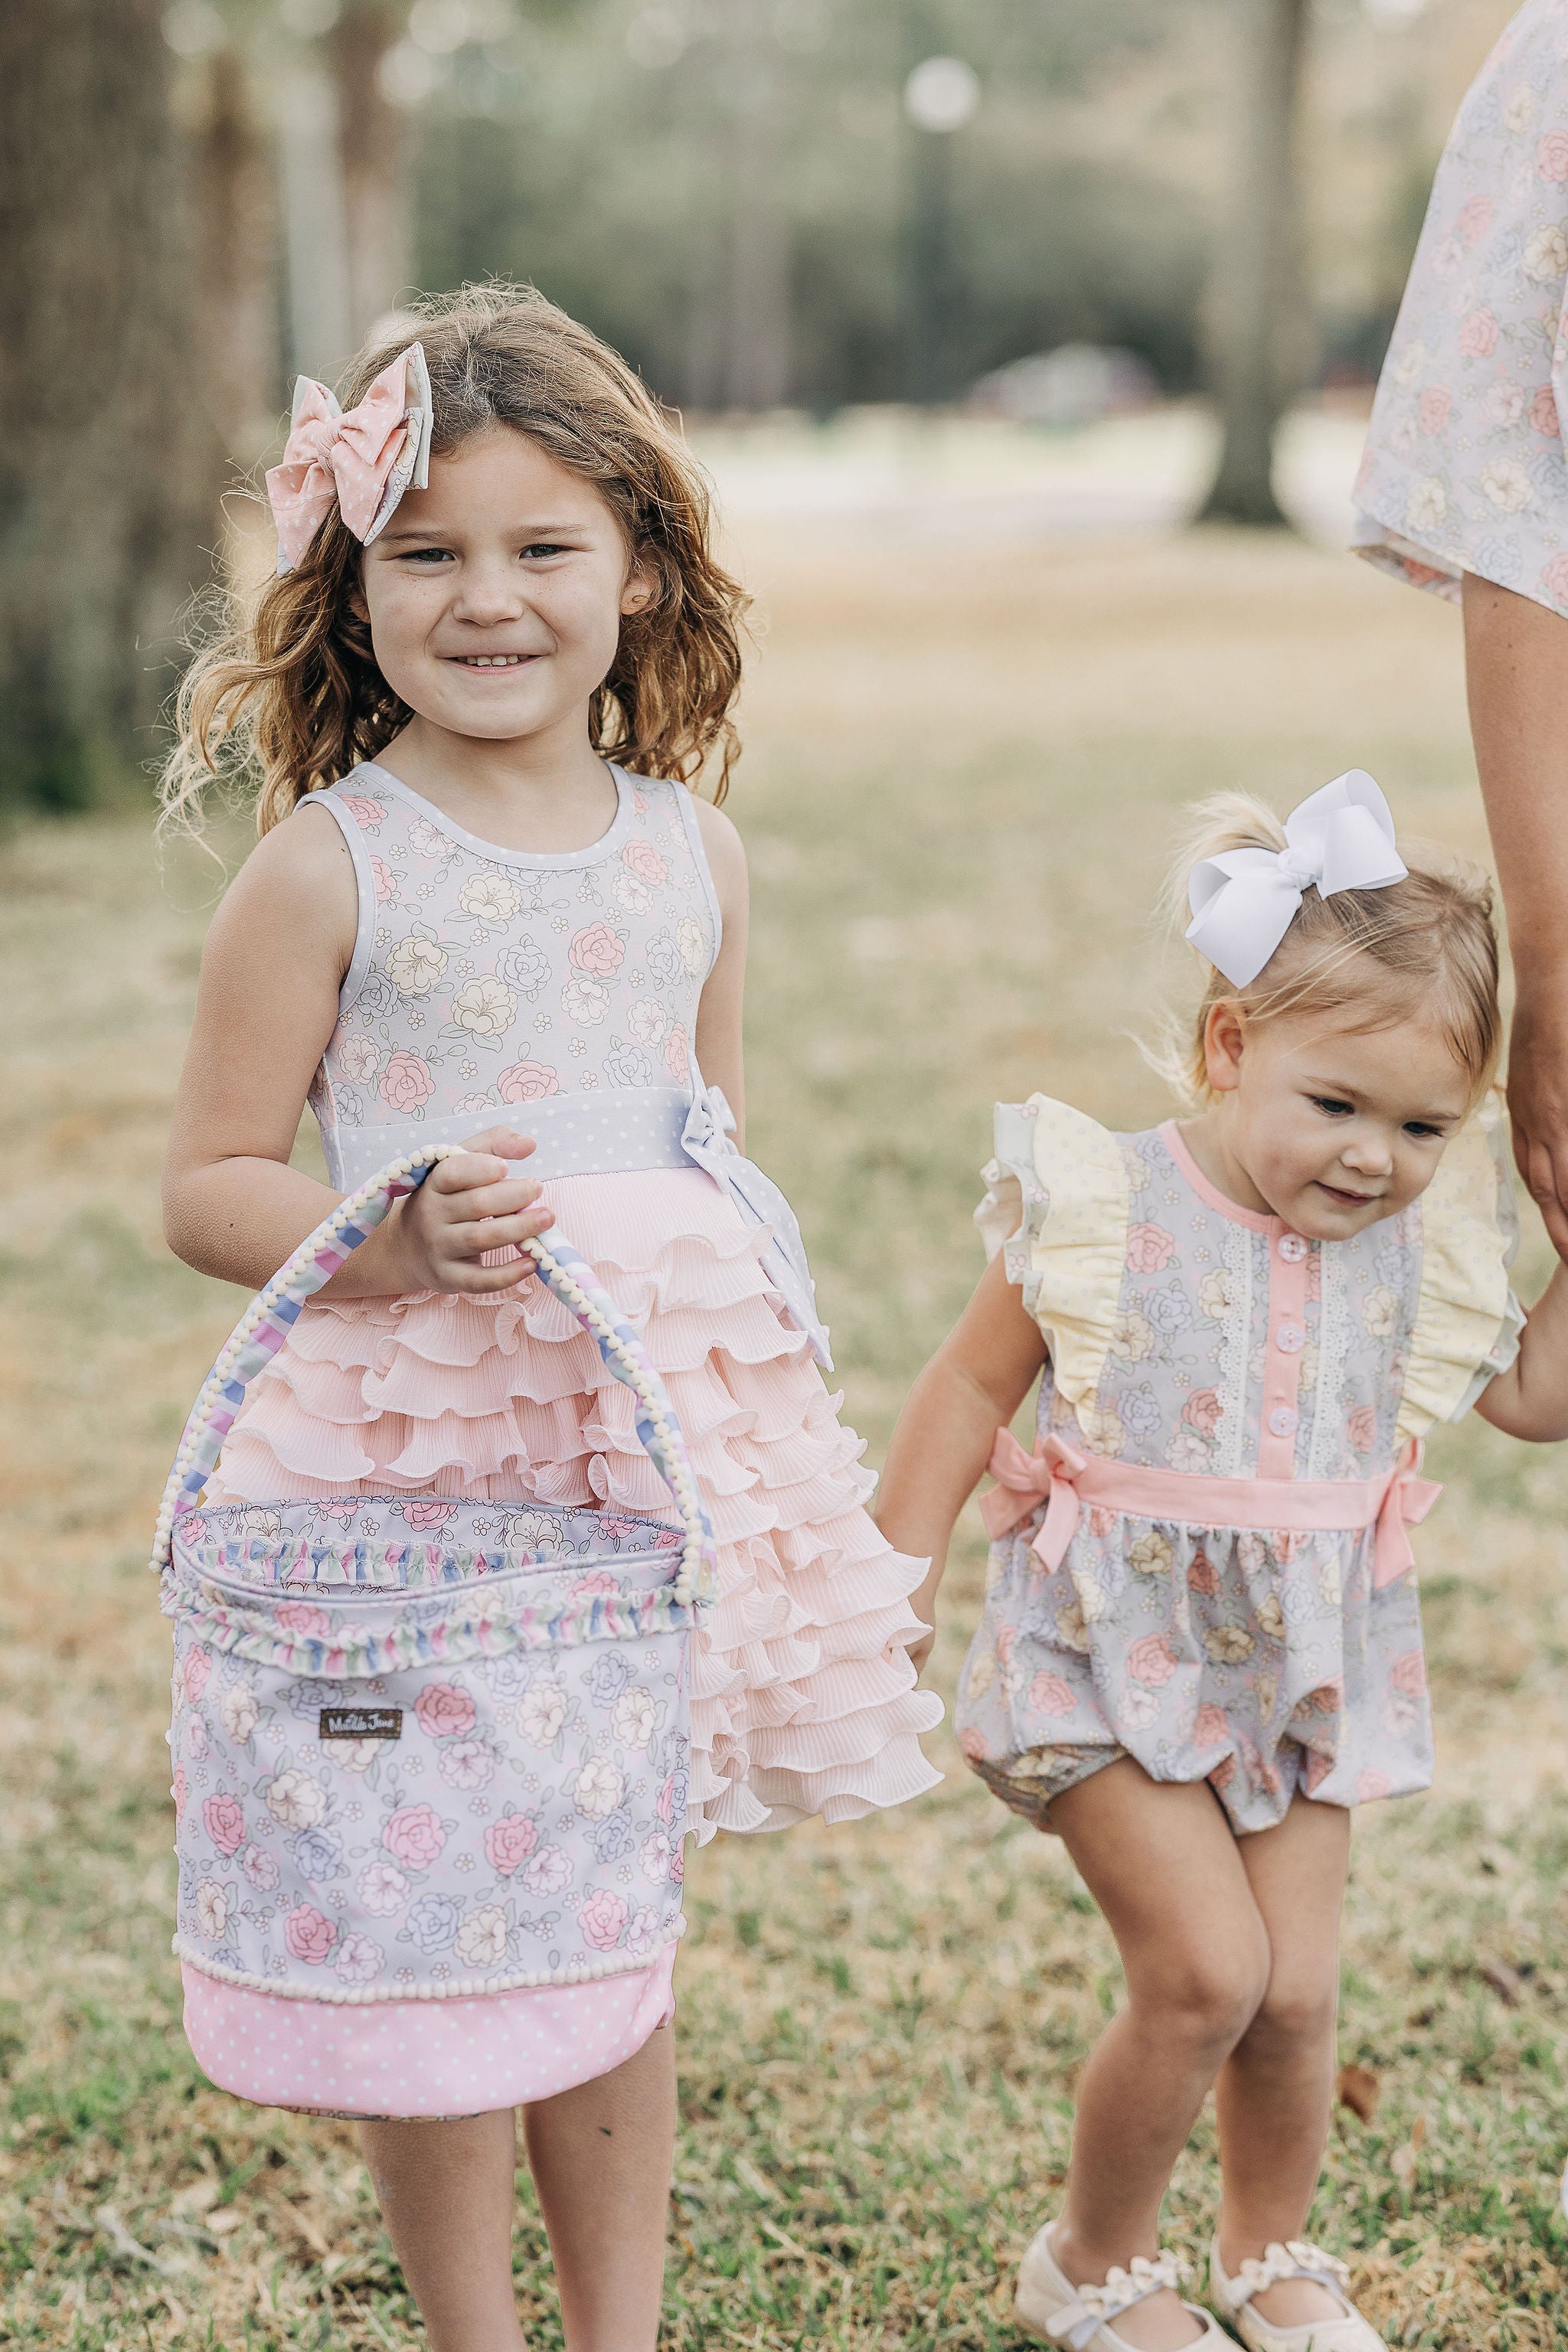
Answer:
167, 289, 940, 2352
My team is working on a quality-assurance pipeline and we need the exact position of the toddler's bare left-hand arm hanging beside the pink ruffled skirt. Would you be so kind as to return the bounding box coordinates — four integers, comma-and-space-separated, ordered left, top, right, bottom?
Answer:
877, 1256, 1046, 1665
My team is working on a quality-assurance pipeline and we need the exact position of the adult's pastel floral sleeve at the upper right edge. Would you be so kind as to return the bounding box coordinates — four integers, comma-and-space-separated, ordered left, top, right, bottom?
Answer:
1352, 0, 1568, 614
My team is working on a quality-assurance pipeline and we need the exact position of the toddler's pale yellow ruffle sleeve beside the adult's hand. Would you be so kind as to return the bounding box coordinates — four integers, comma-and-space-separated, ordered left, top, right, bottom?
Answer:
1399, 1099, 1524, 1437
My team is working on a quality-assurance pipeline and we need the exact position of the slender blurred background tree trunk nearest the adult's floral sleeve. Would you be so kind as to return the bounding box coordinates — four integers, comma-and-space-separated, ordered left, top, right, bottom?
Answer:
1201, 0, 1309, 529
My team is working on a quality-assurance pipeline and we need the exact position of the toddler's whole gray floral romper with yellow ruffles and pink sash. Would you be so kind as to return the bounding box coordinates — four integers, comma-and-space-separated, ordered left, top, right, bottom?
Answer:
957, 1096, 1524, 1832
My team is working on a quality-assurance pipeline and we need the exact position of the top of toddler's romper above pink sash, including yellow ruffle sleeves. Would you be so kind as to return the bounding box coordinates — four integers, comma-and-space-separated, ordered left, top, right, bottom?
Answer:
978, 1096, 1524, 1479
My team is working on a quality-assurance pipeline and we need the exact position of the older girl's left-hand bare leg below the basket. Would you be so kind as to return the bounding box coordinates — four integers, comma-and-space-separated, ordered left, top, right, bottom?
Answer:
360, 2108, 524, 2352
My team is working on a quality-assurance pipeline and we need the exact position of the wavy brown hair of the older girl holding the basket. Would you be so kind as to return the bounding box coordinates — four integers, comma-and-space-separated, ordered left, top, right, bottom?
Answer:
162, 285, 747, 832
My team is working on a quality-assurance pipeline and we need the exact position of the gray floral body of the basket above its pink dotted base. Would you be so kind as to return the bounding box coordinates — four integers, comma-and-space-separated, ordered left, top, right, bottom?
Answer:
165, 1543, 691, 2001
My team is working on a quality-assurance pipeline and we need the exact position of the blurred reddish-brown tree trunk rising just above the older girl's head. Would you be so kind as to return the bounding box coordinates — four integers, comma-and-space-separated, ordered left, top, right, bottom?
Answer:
332, 0, 409, 344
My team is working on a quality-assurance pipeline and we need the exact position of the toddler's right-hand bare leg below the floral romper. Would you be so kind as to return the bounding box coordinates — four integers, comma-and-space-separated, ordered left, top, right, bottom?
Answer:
1215, 1797, 1349, 2328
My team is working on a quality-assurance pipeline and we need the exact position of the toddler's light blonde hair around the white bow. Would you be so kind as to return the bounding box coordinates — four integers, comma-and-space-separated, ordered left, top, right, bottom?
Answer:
1149, 792, 1502, 1110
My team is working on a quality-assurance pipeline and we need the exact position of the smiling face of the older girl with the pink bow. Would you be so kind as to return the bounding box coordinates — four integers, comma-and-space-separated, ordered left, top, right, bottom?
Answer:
364, 426, 648, 741
